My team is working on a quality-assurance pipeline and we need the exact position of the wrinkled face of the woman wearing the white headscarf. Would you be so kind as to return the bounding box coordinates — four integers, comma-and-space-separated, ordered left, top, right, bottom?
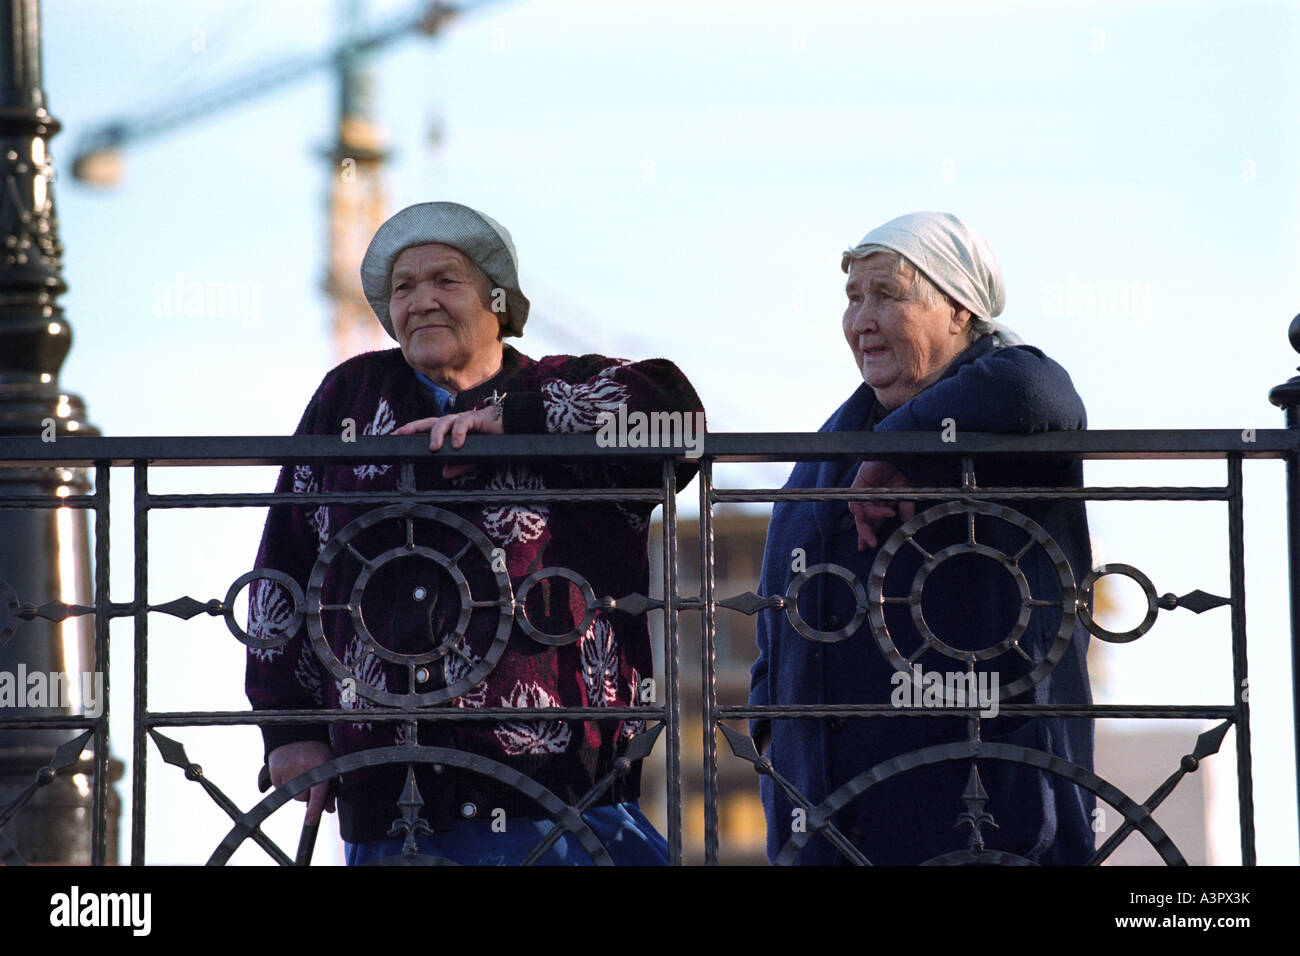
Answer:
844, 252, 971, 408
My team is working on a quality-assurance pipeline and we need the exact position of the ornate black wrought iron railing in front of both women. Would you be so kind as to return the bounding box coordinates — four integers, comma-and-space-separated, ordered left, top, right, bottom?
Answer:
0, 429, 1300, 865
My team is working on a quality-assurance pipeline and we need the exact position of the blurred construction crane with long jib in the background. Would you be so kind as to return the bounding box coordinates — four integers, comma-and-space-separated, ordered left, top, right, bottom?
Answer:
73, 0, 491, 362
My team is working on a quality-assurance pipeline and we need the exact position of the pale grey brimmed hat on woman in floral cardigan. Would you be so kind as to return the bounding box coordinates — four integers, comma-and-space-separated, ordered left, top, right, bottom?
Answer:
361, 203, 528, 339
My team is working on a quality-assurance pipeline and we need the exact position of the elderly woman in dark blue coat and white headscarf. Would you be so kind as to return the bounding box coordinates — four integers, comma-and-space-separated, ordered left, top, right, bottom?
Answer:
750, 213, 1095, 865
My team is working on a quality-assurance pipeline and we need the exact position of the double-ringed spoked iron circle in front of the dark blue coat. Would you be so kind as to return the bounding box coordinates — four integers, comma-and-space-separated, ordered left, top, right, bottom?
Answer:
867, 501, 1078, 706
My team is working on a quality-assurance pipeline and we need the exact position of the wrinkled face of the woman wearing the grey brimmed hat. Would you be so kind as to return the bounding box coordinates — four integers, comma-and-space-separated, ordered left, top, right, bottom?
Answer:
389, 243, 502, 392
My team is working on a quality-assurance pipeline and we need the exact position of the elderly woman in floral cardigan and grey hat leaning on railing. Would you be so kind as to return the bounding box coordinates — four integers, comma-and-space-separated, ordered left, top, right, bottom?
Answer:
246, 203, 702, 864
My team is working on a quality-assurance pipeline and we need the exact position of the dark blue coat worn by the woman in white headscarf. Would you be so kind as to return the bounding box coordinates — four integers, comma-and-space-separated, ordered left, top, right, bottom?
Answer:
750, 336, 1095, 865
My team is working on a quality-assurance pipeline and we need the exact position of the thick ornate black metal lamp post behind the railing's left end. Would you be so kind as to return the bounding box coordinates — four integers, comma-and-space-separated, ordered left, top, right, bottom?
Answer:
0, 0, 116, 864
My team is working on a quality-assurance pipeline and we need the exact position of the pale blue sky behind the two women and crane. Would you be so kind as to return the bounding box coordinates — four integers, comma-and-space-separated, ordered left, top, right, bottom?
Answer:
35, 0, 1300, 862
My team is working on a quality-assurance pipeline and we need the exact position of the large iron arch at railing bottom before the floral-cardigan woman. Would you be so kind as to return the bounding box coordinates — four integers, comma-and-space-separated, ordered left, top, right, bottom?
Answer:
207, 744, 614, 866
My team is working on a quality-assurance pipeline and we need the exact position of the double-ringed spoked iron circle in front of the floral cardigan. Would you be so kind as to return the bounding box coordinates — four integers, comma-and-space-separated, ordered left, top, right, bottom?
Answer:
307, 505, 515, 708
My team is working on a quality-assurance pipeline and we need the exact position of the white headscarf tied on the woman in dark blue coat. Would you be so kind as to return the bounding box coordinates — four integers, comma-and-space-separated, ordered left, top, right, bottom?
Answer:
840, 212, 1022, 345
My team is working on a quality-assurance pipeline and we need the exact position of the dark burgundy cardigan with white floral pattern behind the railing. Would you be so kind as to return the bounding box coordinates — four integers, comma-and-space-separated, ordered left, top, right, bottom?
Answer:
246, 346, 702, 842
